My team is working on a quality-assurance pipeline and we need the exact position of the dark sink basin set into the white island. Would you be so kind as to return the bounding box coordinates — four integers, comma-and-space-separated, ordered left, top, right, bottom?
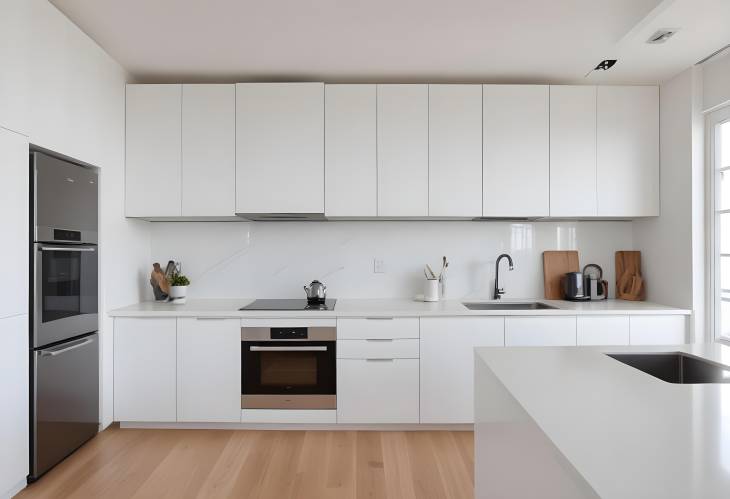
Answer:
606, 352, 730, 385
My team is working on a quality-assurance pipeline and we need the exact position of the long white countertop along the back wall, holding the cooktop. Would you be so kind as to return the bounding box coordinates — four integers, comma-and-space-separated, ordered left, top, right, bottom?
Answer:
109, 298, 691, 318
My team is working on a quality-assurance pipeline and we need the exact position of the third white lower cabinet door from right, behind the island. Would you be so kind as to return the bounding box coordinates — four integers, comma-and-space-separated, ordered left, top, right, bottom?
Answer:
504, 317, 577, 347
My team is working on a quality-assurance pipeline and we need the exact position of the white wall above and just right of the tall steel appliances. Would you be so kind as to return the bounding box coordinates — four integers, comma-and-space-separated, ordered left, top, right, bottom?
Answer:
0, 0, 150, 458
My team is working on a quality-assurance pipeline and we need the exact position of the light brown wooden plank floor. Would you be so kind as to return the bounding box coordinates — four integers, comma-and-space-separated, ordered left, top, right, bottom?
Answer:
16, 425, 474, 499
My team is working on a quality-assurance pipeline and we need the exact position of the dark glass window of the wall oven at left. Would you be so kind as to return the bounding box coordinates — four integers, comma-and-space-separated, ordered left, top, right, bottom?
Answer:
40, 251, 98, 322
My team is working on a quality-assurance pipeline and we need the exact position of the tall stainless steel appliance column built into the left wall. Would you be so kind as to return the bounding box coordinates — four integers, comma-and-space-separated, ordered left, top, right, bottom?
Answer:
28, 152, 99, 482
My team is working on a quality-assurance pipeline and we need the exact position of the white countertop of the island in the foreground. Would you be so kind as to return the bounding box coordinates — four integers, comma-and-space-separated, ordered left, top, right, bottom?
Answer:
476, 344, 730, 499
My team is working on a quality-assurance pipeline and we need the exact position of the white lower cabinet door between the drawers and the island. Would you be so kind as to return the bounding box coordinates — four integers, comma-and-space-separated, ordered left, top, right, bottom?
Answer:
421, 317, 504, 423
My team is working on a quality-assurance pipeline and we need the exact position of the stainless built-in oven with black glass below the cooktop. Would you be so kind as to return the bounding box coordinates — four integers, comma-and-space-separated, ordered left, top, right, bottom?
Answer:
241, 327, 337, 409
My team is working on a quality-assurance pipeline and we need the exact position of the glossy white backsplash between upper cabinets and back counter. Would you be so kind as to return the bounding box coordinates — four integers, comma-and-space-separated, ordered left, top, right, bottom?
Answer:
148, 221, 633, 299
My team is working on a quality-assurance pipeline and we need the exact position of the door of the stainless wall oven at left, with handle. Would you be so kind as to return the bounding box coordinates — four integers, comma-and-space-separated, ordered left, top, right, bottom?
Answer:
33, 243, 99, 348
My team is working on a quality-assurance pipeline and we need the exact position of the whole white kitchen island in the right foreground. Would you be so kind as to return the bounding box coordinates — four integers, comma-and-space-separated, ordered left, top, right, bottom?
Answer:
475, 344, 730, 499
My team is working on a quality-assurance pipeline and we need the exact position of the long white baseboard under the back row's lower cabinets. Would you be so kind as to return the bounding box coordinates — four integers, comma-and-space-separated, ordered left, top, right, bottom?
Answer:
119, 421, 474, 431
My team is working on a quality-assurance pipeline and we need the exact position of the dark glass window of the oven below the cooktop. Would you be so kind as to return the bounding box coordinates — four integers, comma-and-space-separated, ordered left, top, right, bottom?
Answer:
261, 352, 317, 389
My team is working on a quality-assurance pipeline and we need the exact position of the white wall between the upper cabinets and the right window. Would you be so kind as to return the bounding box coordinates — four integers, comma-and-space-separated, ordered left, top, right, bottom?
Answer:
634, 68, 704, 341
